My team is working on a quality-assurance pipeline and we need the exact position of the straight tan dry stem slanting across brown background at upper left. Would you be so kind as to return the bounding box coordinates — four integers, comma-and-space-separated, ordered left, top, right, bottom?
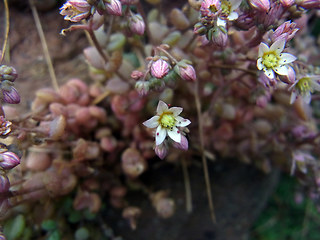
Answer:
29, 0, 59, 91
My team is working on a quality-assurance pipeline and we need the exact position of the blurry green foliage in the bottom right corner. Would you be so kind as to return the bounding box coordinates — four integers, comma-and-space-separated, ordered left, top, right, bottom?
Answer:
250, 176, 320, 240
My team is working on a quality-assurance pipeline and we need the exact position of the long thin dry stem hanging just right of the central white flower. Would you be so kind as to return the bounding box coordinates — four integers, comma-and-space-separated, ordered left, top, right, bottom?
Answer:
194, 77, 217, 223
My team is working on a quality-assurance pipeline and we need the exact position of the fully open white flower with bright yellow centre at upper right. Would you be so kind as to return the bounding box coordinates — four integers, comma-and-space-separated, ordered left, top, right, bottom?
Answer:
257, 39, 297, 79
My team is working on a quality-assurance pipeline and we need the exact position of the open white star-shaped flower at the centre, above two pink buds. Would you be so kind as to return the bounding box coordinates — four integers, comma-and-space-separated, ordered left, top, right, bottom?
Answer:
143, 100, 191, 146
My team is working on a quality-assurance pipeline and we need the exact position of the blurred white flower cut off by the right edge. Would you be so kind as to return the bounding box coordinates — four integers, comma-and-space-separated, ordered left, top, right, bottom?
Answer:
289, 75, 320, 104
